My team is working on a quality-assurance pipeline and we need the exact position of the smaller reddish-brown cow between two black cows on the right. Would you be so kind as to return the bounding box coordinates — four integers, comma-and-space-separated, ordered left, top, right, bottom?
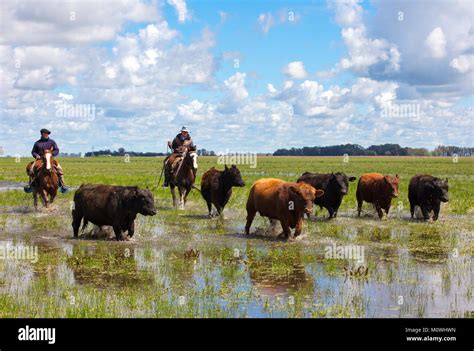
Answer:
356, 173, 400, 219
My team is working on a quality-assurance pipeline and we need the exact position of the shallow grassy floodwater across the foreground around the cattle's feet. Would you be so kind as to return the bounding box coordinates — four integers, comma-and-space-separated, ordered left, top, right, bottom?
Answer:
0, 195, 474, 317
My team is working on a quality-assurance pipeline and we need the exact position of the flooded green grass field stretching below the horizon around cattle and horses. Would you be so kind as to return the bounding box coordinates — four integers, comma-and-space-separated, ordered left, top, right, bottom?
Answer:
0, 157, 474, 318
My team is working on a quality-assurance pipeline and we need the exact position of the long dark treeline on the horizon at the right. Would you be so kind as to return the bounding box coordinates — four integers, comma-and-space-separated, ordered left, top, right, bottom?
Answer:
273, 144, 474, 156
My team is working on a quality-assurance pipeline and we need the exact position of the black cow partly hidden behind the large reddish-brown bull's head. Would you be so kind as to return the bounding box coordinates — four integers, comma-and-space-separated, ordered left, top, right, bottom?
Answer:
297, 172, 356, 218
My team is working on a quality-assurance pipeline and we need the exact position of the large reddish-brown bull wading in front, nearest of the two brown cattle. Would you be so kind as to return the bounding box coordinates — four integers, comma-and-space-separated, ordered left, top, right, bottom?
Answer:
245, 178, 324, 238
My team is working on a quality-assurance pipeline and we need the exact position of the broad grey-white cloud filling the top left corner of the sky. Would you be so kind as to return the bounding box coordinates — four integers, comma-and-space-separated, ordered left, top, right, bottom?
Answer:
0, 0, 161, 46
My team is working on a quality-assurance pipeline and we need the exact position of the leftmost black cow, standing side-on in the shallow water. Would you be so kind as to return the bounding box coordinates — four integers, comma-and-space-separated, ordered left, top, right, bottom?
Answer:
72, 184, 156, 240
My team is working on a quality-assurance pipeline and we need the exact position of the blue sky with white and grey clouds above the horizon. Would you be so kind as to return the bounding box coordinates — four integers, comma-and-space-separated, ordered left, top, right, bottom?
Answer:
0, 0, 474, 155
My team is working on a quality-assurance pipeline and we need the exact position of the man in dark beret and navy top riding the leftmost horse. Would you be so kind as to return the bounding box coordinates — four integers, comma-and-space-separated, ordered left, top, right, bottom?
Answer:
25, 128, 68, 193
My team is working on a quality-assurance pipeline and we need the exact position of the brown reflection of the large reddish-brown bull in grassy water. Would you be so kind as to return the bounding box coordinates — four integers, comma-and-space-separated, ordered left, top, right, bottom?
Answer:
248, 250, 314, 296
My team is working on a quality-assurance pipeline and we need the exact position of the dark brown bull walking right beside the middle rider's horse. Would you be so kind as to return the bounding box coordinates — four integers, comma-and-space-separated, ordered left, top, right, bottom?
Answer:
201, 165, 245, 217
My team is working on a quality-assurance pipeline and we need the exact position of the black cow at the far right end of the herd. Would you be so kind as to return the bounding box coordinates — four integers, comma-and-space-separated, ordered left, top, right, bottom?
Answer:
408, 174, 449, 221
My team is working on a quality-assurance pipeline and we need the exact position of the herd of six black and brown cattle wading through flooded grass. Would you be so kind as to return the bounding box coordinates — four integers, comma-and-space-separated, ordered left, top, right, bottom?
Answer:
72, 165, 448, 240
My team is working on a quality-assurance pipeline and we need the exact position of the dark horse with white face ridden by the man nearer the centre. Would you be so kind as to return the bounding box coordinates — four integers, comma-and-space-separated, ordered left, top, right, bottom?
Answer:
170, 146, 198, 210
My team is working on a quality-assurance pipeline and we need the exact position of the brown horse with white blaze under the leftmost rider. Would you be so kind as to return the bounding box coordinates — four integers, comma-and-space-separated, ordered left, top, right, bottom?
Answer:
26, 150, 59, 209
